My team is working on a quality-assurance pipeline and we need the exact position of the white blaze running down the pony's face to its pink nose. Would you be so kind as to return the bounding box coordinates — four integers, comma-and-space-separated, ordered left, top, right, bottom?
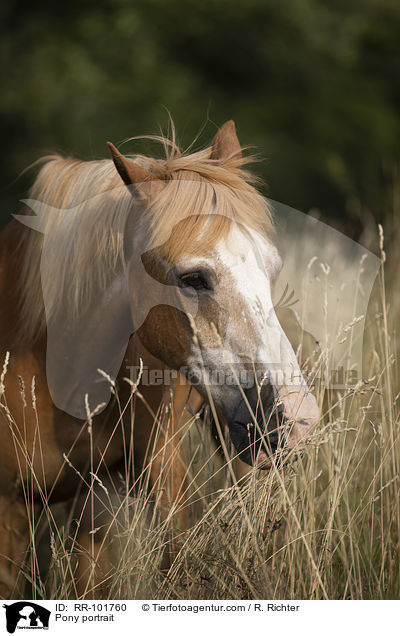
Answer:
217, 226, 319, 432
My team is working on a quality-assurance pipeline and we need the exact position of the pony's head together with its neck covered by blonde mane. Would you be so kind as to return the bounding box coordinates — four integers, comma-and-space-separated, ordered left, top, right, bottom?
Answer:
18, 121, 320, 467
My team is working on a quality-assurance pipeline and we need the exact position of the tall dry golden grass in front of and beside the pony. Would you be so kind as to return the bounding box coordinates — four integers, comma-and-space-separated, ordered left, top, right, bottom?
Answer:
0, 225, 400, 599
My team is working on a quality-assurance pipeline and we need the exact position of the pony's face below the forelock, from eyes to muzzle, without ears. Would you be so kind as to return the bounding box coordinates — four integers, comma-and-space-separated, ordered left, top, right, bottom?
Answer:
135, 224, 319, 467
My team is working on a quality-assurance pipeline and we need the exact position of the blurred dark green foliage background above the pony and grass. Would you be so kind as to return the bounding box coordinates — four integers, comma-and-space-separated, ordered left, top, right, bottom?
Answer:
0, 0, 400, 245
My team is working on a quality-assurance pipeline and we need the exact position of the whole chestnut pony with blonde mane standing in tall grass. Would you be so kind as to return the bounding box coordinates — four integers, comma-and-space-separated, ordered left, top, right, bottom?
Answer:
0, 121, 320, 597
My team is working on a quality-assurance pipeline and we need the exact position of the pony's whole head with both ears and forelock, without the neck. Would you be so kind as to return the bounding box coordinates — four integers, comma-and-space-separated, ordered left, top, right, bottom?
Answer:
109, 121, 320, 467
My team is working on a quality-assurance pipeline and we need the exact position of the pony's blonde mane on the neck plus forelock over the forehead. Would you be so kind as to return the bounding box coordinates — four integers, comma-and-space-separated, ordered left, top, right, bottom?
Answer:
21, 125, 273, 340
